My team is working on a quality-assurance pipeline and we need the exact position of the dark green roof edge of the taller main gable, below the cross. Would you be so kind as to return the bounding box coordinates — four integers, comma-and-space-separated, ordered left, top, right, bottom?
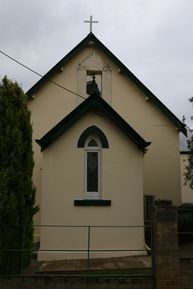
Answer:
26, 33, 187, 135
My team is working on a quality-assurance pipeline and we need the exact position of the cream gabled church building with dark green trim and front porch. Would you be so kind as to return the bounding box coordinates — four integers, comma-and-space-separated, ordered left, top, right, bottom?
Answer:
27, 23, 186, 260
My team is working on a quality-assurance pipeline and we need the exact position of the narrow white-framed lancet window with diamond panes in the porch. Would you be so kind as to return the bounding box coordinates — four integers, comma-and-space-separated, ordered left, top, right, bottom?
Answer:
84, 135, 102, 199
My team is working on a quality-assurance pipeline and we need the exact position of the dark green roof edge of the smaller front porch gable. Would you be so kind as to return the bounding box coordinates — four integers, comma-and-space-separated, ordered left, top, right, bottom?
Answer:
36, 94, 150, 152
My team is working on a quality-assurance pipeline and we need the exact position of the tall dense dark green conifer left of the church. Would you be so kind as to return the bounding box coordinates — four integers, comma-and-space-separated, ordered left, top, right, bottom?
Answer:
0, 76, 37, 274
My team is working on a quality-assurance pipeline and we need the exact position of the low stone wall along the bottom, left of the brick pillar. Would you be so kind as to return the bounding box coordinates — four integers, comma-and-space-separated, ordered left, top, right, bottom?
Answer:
0, 276, 154, 289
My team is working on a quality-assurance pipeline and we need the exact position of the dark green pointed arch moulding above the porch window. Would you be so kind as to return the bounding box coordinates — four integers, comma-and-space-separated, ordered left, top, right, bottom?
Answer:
77, 125, 109, 148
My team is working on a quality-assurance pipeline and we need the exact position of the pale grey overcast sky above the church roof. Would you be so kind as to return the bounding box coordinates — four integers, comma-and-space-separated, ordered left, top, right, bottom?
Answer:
0, 0, 193, 127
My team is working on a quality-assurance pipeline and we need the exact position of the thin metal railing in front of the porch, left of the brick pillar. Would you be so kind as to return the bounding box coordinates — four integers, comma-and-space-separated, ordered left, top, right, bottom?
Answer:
2, 225, 153, 276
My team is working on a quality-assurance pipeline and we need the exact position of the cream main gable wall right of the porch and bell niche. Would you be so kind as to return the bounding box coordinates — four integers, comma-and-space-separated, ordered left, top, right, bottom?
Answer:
112, 63, 181, 205
